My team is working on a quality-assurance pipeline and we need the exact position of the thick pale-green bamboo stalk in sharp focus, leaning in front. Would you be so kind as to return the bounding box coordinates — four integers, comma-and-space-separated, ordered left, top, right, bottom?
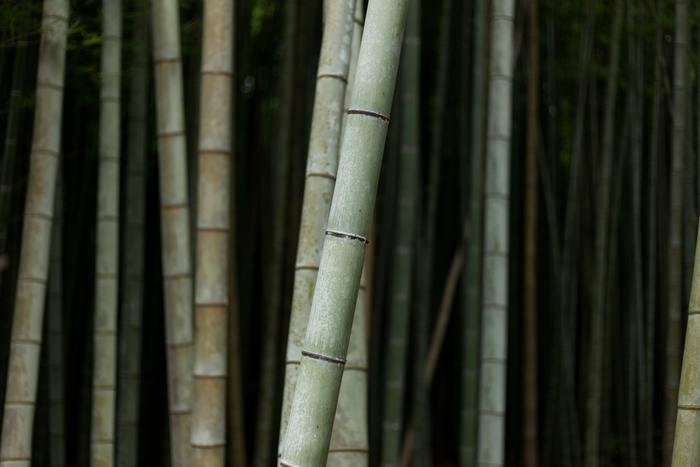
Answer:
280, 0, 408, 467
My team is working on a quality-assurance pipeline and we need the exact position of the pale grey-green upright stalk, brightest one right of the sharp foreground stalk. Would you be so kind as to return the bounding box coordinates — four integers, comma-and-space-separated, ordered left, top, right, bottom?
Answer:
477, 0, 515, 466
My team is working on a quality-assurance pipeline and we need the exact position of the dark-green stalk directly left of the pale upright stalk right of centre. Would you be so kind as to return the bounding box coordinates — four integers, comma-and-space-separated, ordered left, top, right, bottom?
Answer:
459, 0, 487, 460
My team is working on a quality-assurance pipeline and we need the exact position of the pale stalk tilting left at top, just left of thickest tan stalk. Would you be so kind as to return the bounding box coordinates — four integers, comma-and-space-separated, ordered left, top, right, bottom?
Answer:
152, 0, 193, 467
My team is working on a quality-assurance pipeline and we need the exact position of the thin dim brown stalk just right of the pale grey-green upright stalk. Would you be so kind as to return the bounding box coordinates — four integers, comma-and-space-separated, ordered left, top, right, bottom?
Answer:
524, 0, 540, 467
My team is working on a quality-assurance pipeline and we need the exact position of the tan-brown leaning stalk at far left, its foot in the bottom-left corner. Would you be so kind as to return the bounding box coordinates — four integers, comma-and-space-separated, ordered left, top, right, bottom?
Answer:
0, 0, 69, 467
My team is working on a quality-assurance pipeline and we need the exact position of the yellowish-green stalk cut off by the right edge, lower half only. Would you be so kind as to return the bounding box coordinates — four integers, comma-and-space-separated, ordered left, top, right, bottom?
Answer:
671, 224, 700, 467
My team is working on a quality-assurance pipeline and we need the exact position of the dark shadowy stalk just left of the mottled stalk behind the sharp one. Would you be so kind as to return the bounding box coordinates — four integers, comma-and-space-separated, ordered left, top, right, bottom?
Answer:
253, 2, 299, 467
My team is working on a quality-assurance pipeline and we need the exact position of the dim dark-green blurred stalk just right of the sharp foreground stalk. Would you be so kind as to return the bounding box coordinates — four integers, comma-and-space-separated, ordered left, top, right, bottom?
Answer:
381, 0, 418, 467
